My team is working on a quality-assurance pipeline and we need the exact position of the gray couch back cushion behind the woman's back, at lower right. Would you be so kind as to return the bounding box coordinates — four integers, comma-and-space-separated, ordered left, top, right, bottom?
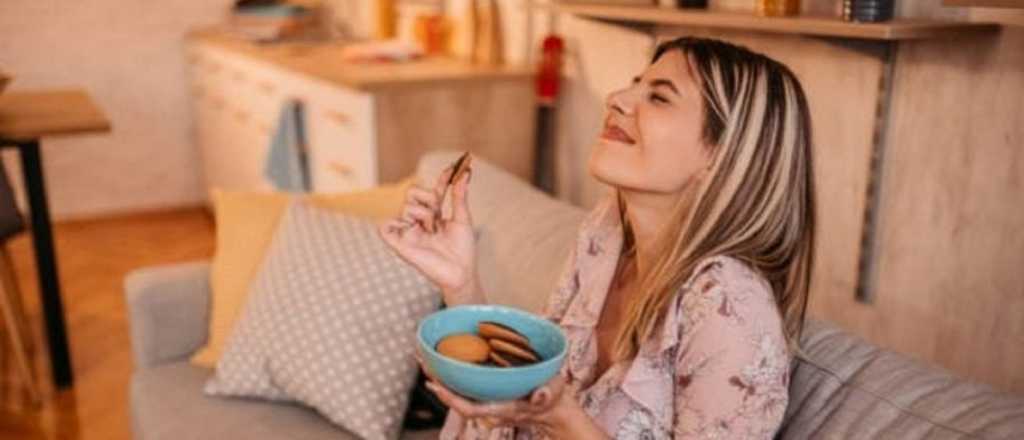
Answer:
779, 320, 1024, 440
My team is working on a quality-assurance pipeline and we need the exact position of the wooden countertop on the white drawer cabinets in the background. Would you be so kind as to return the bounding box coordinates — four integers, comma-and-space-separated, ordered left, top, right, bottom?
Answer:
187, 30, 534, 90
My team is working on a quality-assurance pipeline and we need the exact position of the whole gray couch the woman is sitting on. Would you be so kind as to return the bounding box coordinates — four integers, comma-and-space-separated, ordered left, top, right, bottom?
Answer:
125, 152, 1024, 440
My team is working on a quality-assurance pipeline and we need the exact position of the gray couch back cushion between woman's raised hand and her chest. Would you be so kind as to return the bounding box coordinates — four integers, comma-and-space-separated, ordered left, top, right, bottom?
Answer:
416, 151, 586, 312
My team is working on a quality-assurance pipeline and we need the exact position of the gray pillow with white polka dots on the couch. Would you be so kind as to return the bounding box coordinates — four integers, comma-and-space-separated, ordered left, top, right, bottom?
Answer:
205, 202, 440, 439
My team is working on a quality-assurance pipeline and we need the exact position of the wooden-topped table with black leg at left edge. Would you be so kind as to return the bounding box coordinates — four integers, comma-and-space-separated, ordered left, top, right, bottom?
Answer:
0, 90, 111, 389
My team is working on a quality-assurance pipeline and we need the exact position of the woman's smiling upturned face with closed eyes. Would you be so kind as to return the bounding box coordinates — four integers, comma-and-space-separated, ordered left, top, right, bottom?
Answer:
590, 50, 711, 194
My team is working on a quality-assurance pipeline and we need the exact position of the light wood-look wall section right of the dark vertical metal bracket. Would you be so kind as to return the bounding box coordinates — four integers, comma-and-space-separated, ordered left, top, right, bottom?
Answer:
816, 18, 1024, 392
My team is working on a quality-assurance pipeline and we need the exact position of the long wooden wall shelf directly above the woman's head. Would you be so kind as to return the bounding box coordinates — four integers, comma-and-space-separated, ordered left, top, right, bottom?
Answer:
555, 4, 999, 41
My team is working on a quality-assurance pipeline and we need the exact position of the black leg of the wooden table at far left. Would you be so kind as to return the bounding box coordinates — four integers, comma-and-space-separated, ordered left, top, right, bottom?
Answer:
17, 139, 74, 389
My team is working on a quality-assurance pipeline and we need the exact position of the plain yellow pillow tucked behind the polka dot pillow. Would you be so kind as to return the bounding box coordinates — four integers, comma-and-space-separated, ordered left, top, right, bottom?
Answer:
191, 178, 414, 368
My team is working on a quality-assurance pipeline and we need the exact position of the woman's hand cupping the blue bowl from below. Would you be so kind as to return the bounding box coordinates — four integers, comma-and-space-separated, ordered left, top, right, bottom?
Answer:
420, 352, 582, 438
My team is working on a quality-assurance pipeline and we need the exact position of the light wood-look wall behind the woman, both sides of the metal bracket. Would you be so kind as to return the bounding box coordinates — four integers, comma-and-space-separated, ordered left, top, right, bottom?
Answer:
491, 0, 1024, 392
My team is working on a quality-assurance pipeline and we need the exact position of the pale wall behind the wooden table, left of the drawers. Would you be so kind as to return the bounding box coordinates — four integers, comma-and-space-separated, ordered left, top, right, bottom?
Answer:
0, 0, 229, 219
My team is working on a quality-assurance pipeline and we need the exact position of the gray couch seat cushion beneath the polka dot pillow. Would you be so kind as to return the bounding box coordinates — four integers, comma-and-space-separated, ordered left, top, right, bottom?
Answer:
131, 361, 439, 440
